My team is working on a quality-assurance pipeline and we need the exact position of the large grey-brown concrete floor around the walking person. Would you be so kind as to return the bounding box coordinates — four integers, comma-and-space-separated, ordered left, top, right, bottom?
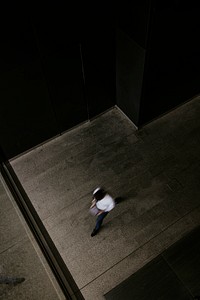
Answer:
11, 97, 200, 300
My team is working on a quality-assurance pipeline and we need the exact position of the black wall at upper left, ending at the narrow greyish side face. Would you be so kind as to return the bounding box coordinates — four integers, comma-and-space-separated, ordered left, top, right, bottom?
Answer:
0, 3, 115, 158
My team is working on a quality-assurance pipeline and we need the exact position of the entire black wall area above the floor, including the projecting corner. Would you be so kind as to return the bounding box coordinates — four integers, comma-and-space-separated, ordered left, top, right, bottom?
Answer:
0, 0, 200, 158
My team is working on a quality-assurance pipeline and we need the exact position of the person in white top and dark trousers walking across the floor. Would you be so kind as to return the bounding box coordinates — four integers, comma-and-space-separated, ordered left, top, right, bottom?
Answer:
90, 187, 115, 237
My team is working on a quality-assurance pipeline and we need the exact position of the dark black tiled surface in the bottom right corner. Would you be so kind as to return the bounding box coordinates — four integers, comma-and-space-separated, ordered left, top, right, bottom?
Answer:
105, 226, 200, 300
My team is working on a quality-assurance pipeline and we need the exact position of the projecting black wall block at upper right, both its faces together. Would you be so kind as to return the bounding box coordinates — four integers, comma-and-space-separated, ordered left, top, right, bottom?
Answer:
116, 0, 200, 127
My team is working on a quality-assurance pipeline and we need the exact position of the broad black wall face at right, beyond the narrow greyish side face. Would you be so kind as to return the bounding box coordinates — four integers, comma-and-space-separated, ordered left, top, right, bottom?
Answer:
139, 0, 200, 126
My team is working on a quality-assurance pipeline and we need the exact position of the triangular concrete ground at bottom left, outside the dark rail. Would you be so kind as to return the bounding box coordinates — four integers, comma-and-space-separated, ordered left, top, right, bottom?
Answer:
0, 177, 64, 300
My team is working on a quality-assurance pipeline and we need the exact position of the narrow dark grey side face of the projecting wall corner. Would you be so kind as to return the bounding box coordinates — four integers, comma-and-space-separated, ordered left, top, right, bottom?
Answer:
116, 28, 146, 126
